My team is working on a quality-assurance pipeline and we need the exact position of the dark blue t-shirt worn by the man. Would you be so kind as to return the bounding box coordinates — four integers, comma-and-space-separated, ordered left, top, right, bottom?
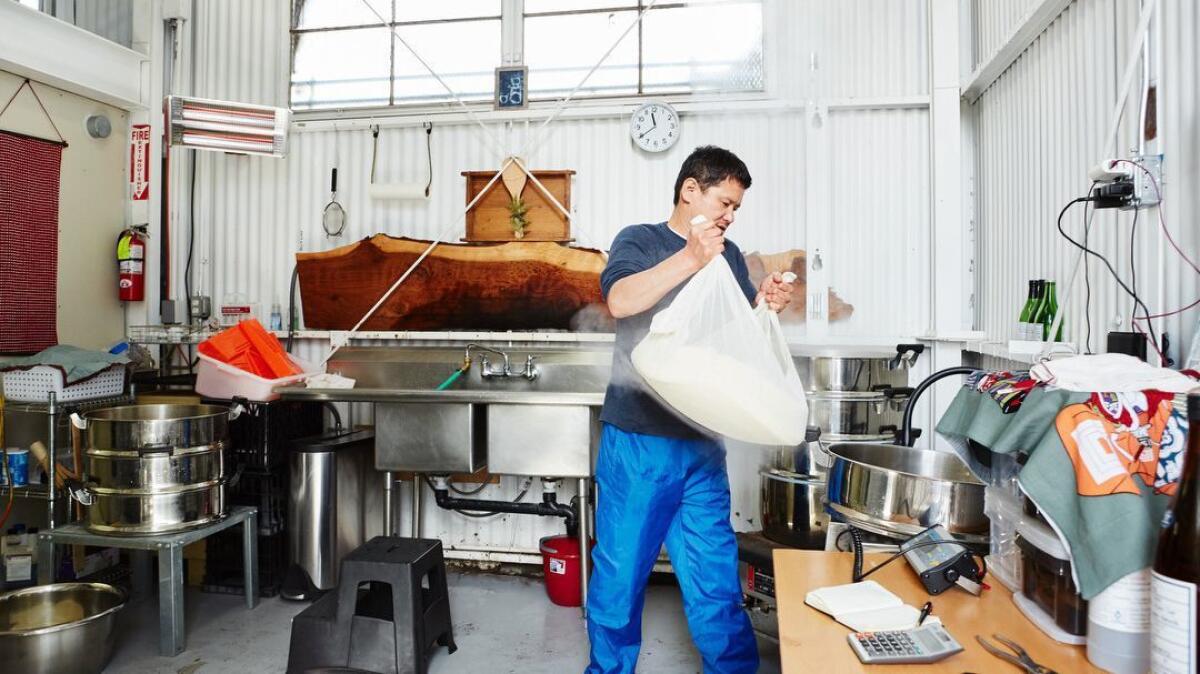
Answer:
600, 222, 758, 438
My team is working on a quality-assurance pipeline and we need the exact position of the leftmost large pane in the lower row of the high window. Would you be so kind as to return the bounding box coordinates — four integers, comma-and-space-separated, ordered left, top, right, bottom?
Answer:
292, 28, 391, 110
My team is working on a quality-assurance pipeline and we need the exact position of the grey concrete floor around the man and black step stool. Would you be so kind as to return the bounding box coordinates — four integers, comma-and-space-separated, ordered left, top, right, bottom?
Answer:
104, 573, 780, 674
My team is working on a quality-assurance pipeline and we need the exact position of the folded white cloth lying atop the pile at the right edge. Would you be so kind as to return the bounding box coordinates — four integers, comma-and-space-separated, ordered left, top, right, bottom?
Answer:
1030, 354, 1200, 393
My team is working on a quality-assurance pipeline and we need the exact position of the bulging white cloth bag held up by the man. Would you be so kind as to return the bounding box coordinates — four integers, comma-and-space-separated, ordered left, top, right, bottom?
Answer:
631, 255, 809, 445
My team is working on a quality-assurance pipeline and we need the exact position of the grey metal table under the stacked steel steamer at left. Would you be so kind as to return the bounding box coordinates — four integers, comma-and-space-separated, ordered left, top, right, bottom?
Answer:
37, 506, 258, 657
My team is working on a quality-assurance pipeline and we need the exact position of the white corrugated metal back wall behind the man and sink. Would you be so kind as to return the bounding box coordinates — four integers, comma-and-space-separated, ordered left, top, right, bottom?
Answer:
173, 0, 930, 552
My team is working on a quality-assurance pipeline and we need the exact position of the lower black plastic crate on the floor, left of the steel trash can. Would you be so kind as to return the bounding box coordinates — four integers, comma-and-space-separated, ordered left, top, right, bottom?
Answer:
200, 526, 288, 597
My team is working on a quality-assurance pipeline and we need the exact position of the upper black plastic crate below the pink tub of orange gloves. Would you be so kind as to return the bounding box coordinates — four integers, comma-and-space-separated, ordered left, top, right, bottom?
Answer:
203, 398, 325, 470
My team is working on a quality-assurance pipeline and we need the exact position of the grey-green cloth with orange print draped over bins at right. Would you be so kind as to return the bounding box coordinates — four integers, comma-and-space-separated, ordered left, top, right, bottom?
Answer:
937, 386, 1187, 600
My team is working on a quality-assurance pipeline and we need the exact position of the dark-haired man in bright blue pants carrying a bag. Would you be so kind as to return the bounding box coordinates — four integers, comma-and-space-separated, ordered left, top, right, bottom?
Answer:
587, 146, 792, 674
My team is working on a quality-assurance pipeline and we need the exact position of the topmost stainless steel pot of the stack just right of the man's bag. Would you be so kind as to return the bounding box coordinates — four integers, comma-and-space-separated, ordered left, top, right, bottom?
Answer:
792, 344, 924, 393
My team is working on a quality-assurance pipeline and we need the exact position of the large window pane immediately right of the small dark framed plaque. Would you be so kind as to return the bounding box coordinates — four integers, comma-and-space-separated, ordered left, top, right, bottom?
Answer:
524, 11, 637, 97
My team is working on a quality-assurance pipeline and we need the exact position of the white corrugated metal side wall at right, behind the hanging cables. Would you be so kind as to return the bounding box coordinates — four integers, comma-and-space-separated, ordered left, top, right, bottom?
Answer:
970, 0, 1200, 361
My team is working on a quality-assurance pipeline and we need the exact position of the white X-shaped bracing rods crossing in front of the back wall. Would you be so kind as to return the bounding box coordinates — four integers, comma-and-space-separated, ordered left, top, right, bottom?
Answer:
320, 0, 658, 366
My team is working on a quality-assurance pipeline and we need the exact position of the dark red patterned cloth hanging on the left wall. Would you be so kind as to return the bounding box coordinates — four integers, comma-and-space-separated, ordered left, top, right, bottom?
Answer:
0, 131, 62, 353
